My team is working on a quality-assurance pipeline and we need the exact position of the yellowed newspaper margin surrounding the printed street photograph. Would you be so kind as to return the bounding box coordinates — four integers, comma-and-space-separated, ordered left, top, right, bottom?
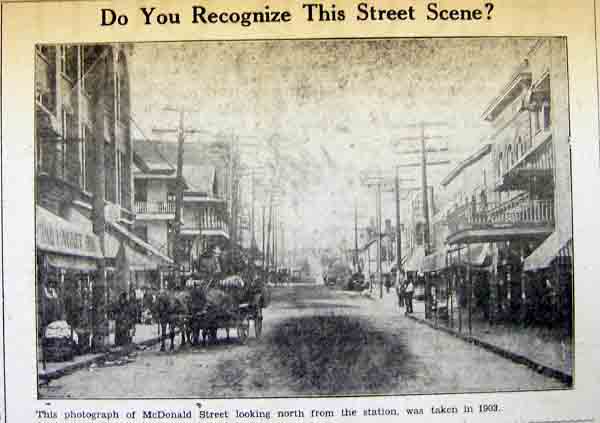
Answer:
2, 0, 600, 422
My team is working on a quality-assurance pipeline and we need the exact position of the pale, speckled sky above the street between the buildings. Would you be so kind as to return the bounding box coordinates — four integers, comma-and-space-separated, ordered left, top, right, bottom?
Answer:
129, 38, 535, 255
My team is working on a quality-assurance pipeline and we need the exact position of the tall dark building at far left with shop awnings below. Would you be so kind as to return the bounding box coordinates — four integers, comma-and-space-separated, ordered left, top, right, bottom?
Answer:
35, 45, 170, 350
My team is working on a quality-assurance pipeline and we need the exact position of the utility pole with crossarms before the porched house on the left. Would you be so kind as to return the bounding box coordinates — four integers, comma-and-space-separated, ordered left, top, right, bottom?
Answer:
152, 107, 203, 268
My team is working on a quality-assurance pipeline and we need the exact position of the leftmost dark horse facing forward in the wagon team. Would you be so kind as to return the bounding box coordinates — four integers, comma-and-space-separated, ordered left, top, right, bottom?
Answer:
155, 291, 190, 351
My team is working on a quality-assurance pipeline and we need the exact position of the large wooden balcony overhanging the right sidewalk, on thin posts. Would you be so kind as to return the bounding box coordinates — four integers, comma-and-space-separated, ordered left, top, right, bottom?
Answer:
446, 196, 554, 244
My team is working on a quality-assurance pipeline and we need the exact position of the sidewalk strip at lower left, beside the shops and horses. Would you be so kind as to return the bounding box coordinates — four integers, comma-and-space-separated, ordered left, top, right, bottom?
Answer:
38, 324, 160, 383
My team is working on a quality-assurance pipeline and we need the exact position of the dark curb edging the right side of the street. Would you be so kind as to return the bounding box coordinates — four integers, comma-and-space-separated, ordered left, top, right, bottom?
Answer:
406, 314, 573, 386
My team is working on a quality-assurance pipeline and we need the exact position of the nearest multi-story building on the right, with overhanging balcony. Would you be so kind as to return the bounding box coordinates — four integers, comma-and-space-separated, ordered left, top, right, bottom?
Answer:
448, 38, 572, 324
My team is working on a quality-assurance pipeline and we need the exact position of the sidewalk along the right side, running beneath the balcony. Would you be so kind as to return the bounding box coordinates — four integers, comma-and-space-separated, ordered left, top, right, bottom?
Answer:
376, 292, 573, 384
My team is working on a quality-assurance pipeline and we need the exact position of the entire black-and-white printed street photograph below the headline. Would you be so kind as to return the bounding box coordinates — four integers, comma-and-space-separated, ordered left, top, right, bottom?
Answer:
34, 37, 574, 399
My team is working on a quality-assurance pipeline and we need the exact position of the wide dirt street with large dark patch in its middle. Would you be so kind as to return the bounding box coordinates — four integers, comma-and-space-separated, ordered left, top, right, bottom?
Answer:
39, 285, 563, 398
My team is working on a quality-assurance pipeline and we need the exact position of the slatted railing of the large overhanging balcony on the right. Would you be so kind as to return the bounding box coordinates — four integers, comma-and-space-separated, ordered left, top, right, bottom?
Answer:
448, 197, 554, 235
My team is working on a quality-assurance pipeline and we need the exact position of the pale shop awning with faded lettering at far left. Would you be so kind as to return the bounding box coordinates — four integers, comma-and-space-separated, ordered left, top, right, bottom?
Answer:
35, 206, 102, 258
